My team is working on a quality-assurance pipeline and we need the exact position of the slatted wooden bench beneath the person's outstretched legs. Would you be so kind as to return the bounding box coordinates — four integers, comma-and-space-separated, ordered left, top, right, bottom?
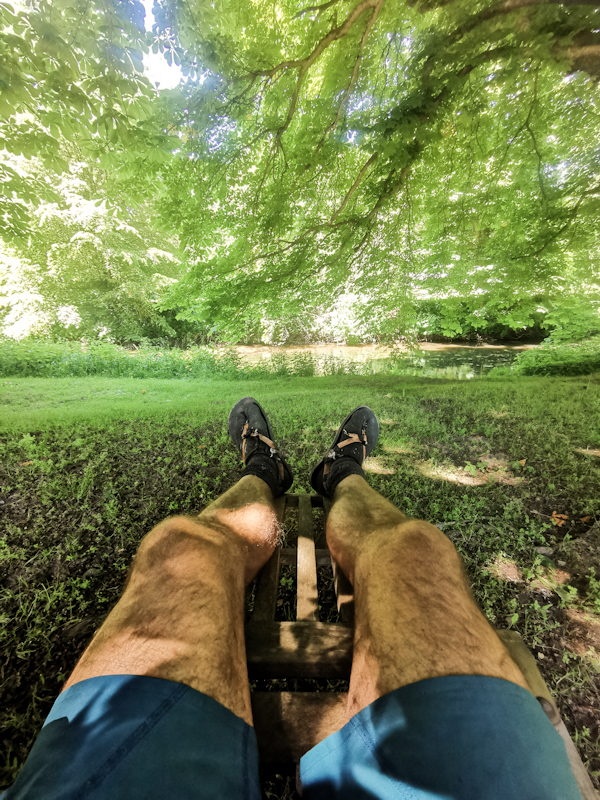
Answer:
246, 494, 598, 800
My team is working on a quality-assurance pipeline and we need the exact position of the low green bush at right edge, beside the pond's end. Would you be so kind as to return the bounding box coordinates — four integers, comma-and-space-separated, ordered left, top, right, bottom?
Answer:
506, 336, 600, 375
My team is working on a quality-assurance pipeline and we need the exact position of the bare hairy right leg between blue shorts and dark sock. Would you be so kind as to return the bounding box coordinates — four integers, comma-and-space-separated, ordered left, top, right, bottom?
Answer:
327, 475, 528, 716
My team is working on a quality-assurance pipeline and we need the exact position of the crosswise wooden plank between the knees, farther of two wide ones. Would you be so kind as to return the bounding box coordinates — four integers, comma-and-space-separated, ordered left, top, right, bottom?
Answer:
246, 620, 353, 679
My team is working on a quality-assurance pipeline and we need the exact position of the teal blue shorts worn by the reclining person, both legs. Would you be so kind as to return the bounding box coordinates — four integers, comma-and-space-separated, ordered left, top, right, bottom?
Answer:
2, 675, 581, 800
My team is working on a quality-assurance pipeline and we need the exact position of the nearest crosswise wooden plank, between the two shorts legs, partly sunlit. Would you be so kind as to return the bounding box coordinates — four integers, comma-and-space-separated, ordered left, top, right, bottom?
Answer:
252, 692, 348, 764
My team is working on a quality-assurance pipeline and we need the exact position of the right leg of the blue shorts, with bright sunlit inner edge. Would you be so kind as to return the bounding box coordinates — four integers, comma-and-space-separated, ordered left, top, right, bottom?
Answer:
300, 675, 581, 800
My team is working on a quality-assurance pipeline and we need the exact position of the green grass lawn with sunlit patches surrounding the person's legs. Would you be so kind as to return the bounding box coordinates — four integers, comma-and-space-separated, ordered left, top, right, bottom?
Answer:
0, 375, 600, 786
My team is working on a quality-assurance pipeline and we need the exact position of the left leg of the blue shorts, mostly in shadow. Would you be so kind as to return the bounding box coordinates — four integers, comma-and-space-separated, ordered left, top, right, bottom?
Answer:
3, 675, 260, 800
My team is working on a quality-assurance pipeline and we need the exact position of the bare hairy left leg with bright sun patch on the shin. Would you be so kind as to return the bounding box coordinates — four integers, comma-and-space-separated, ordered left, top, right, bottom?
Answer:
64, 475, 279, 724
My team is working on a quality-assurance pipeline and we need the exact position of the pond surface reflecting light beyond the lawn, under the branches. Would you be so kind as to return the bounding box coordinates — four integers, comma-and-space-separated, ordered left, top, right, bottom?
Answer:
235, 342, 537, 379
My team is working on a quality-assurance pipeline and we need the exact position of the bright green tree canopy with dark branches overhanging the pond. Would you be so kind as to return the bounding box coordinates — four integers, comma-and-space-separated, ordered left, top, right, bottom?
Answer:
0, 0, 600, 337
